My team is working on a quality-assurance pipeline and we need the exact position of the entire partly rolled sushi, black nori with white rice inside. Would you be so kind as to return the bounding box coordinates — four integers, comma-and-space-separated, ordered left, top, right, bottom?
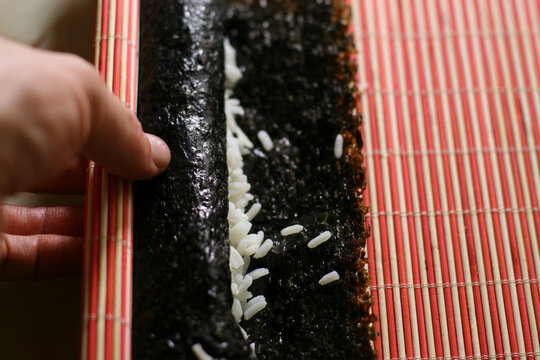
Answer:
133, 0, 374, 360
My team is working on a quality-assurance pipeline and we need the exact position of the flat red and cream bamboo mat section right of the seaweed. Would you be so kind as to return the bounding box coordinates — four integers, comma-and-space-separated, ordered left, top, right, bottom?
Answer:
352, 0, 540, 359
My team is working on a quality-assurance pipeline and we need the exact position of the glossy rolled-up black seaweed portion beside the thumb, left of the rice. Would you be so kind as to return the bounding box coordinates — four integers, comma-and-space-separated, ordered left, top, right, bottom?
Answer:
133, 0, 253, 360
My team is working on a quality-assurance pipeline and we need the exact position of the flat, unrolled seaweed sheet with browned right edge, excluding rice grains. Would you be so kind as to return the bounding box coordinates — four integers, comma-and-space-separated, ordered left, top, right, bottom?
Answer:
226, 0, 374, 359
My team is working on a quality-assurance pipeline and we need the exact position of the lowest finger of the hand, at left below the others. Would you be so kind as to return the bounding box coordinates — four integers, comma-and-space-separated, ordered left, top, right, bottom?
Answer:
0, 234, 82, 280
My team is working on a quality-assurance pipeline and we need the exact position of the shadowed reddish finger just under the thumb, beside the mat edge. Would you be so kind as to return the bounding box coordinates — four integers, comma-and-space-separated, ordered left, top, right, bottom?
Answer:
33, 156, 88, 194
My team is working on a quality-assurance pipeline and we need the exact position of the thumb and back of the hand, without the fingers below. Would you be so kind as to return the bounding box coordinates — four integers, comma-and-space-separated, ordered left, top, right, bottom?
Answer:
0, 43, 170, 196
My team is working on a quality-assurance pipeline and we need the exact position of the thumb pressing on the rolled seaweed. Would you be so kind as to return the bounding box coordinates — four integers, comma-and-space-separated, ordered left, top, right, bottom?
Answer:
78, 65, 171, 180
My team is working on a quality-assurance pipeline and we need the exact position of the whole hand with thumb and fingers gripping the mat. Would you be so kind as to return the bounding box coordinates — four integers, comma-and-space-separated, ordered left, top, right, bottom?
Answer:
0, 38, 170, 279
